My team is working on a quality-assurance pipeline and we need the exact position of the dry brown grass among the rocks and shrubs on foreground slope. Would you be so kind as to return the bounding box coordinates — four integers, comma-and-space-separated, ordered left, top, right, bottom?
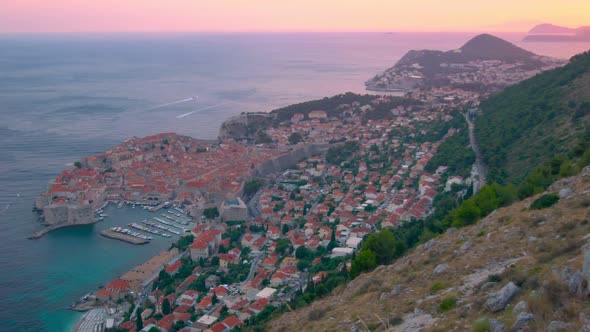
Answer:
269, 174, 590, 332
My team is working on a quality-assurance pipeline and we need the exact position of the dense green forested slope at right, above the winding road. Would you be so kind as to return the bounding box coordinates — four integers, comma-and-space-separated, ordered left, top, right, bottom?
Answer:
475, 52, 590, 183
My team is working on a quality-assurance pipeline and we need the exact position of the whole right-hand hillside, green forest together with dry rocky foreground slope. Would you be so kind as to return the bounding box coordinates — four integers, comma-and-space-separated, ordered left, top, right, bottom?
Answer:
270, 53, 590, 331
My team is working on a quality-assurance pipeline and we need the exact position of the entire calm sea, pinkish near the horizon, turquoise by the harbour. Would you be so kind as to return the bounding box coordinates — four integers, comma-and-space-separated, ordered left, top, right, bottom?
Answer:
0, 32, 590, 331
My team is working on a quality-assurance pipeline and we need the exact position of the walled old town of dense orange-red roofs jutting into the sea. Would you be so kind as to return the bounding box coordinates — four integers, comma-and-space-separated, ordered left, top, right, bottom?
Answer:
32, 131, 330, 238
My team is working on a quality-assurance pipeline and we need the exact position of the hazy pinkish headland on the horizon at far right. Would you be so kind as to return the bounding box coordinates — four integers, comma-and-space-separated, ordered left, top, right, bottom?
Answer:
523, 23, 590, 42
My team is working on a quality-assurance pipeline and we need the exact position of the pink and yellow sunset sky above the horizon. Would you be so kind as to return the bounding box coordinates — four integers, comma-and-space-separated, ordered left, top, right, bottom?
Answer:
0, 0, 590, 33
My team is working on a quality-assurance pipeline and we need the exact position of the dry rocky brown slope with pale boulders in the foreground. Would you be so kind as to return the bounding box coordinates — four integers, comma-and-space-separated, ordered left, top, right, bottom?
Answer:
267, 167, 590, 331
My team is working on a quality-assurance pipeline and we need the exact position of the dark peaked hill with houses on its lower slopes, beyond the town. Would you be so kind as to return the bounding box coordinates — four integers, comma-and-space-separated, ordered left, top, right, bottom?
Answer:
365, 34, 560, 91
